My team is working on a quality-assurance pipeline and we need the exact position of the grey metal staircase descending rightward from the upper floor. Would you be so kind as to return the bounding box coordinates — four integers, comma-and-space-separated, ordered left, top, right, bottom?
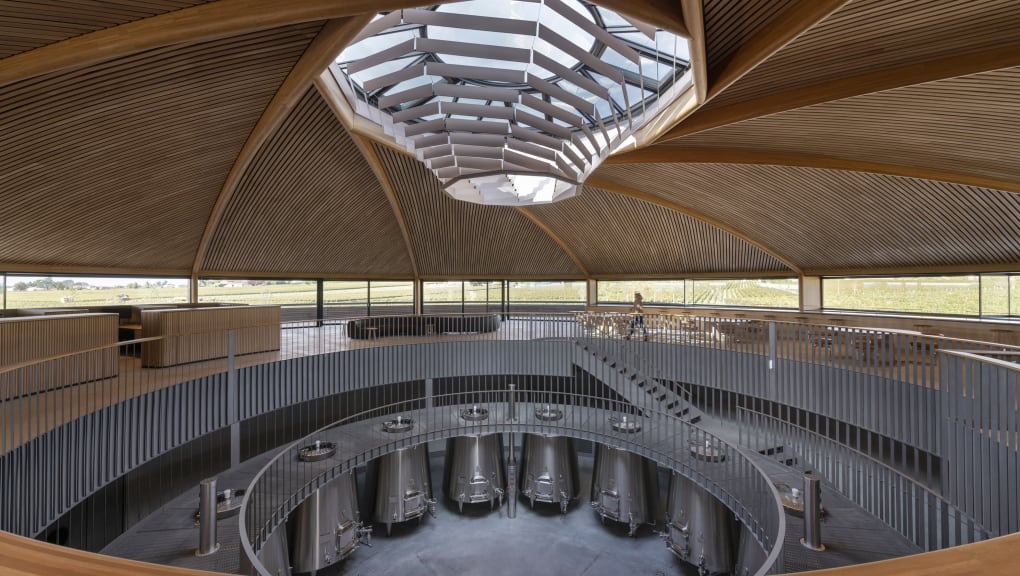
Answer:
574, 339, 704, 424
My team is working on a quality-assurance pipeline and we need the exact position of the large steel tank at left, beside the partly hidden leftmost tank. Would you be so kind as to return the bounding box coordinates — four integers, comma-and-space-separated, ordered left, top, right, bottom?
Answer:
287, 470, 370, 574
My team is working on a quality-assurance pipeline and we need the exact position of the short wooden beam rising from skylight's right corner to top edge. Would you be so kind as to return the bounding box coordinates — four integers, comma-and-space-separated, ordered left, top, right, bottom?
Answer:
708, 0, 850, 100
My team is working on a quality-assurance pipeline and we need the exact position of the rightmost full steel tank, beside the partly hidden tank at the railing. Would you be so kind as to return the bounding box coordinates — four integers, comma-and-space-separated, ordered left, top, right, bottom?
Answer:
666, 472, 738, 574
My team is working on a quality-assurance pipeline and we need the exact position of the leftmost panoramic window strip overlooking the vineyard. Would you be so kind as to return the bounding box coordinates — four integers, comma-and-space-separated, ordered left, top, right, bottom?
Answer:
4, 274, 189, 309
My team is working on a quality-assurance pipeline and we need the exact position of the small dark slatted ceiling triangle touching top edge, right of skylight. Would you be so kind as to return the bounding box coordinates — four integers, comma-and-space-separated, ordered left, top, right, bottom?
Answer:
704, 0, 795, 73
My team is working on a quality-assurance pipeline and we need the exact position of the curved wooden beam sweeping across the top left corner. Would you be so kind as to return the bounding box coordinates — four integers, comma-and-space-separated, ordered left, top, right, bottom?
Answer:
0, 0, 451, 87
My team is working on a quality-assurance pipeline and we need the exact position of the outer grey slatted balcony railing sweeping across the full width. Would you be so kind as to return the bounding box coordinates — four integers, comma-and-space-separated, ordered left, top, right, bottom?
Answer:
0, 313, 1020, 570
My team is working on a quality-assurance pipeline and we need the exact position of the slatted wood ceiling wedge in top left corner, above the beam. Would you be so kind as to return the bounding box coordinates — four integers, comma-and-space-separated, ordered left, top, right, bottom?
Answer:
0, 0, 209, 58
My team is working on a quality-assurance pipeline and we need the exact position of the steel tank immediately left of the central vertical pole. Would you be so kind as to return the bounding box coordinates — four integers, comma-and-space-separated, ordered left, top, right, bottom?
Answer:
443, 434, 507, 512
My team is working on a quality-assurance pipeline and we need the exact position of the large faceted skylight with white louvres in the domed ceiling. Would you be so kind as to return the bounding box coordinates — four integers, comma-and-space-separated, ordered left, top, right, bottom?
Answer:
330, 0, 692, 205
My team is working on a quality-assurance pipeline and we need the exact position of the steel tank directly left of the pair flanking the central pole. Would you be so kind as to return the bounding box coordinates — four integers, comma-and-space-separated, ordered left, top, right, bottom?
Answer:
375, 443, 436, 535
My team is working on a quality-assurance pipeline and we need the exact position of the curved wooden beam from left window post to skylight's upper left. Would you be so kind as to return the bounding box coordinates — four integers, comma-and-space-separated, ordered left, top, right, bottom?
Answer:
192, 14, 372, 274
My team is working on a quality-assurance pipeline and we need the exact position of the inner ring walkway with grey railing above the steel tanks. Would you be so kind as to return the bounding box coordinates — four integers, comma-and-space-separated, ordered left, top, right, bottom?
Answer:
240, 387, 785, 576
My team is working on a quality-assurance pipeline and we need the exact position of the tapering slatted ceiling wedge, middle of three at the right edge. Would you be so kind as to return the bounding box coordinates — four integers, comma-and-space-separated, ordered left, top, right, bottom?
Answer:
669, 68, 1020, 181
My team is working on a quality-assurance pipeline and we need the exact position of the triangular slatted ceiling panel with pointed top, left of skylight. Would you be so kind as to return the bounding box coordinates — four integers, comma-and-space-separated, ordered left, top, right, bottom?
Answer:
204, 89, 412, 277
